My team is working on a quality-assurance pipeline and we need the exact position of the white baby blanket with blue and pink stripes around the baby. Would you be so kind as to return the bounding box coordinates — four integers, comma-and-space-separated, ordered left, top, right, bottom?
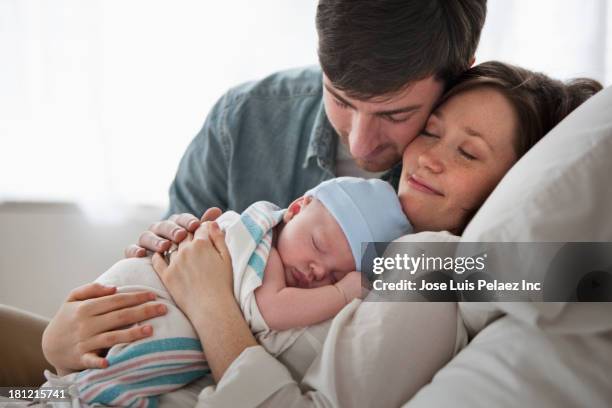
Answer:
58, 201, 302, 407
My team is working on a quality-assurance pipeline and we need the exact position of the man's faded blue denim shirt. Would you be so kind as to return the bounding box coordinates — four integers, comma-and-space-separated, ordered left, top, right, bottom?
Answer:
167, 67, 402, 217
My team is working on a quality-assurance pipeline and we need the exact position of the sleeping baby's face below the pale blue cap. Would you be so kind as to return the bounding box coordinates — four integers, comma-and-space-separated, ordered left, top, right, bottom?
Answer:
276, 197, 355, 288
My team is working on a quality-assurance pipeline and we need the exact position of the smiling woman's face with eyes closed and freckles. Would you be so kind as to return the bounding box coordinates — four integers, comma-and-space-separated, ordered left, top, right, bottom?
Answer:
399, 87, 517, 233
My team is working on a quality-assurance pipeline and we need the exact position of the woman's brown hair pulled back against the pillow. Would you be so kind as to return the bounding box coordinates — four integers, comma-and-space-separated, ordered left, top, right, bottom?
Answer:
438, 61, 602, 157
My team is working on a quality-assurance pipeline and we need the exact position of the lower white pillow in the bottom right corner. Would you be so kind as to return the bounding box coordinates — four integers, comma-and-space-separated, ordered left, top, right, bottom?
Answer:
404, 316, 612, 408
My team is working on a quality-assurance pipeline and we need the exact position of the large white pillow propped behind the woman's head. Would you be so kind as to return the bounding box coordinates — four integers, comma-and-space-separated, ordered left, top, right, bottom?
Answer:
460, 87, 612, 334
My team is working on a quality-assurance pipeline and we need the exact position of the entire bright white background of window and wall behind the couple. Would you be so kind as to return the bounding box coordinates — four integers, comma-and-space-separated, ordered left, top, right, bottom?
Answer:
0, 0, 612, 316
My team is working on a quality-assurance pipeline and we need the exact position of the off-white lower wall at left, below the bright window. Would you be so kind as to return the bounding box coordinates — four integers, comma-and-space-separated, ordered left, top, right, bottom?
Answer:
0, 203, 162, 317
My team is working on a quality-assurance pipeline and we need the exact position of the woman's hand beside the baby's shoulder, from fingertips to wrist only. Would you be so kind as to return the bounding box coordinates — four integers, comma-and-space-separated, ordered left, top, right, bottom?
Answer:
152, 222, 233, 320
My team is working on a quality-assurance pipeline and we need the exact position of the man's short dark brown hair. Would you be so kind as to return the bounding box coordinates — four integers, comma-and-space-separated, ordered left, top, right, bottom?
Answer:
316, 0, 487, 100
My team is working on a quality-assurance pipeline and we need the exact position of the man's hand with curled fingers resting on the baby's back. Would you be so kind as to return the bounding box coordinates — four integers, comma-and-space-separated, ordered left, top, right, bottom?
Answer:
125, 207, 221, 258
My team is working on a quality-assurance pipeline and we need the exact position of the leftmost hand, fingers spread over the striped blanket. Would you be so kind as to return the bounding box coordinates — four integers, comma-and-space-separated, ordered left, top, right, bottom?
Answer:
42, 283, 167, 375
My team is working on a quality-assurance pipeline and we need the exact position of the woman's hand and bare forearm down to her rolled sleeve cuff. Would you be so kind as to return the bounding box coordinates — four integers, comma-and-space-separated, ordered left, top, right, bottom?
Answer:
153, 222, 257, 381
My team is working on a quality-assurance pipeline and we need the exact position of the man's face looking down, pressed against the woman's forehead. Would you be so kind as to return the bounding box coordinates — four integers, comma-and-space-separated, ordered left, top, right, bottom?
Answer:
323, 75, 444, 172
